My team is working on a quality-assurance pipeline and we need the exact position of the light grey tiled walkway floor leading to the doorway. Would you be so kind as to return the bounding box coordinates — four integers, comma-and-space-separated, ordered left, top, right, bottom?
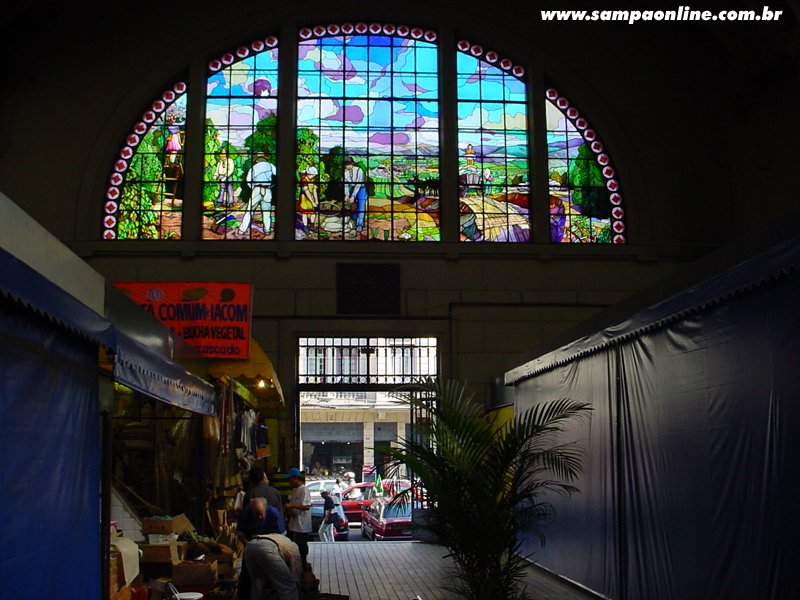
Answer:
308, 541, 599, 600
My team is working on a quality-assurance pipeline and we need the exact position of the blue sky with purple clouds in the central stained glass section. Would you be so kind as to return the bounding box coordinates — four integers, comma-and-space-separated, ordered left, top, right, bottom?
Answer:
297, 35, 439, 155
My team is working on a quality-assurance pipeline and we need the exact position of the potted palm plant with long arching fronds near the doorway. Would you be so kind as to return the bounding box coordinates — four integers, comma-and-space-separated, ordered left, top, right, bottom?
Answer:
382, 379, 590, 600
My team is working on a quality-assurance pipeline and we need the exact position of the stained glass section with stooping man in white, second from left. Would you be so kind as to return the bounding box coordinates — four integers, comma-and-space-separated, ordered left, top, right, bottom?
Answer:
203, 37, 278, 240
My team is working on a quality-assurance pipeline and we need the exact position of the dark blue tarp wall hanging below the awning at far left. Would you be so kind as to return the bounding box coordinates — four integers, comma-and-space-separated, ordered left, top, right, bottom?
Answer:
0, 296, 101, 600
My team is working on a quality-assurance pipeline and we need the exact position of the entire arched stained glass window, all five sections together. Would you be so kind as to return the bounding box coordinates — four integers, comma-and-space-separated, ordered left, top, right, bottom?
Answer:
103, 23, 627, 244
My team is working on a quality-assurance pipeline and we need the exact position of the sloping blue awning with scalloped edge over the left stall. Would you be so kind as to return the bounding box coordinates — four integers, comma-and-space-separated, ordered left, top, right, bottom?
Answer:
0, 248, 215, 415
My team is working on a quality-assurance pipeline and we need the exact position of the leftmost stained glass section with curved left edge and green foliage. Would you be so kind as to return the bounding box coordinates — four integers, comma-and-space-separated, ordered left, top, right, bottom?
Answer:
103, 82, 187, 240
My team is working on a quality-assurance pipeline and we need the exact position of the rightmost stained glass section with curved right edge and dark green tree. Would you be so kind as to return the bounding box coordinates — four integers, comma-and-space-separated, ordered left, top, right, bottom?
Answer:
545, 88, 625, 244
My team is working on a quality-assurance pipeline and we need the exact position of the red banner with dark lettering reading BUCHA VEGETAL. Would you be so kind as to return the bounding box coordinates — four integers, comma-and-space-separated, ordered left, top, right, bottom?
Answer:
114, 281, 253, 359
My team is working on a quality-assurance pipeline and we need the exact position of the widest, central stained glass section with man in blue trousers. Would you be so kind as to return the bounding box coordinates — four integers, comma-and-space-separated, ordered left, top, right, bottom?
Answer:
295, 23, 440, 241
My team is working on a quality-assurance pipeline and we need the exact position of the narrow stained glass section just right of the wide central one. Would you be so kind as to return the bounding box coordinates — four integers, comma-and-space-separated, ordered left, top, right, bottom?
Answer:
457, 40, 531, 242
